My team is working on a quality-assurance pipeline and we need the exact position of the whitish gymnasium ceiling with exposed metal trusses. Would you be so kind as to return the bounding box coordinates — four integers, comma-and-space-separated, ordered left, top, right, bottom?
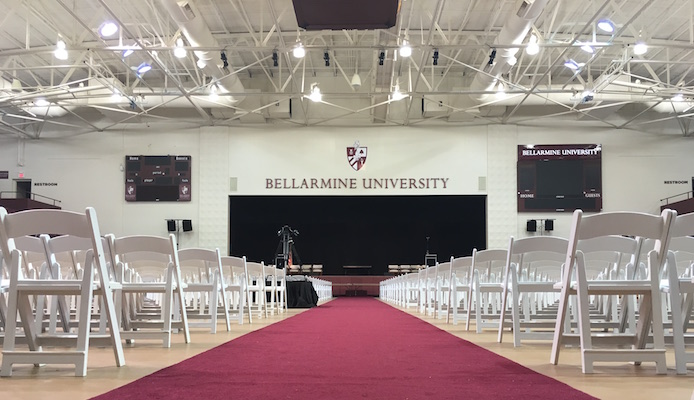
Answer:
0, 0, 694, 138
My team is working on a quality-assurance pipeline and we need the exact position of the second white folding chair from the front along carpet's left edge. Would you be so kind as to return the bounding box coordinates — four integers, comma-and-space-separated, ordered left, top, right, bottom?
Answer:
112, 234, 190, 347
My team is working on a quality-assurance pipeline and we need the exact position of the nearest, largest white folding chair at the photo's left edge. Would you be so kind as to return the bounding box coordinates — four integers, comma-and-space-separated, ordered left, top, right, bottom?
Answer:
0, 207, 125, 376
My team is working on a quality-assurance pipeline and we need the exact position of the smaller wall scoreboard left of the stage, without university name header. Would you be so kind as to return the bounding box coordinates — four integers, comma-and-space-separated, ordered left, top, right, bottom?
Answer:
125, 156, 191, 201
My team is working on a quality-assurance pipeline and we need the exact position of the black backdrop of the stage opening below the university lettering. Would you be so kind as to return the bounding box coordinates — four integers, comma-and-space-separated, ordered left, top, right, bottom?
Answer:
229, 196, 487, 275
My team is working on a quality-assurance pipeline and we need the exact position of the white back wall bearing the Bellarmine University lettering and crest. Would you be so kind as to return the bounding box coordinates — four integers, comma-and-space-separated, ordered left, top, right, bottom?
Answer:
0, 121, 694, 251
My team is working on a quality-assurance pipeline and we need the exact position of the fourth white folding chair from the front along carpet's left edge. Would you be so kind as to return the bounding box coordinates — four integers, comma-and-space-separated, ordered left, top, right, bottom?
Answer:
221, 256, 253, 325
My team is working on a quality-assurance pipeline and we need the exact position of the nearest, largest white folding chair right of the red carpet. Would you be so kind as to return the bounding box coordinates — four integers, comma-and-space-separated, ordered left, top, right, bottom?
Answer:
550, 210, 675, 374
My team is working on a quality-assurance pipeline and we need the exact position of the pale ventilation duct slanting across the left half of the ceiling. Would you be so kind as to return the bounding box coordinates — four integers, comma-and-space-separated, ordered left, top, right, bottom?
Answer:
160, 0, 245, 102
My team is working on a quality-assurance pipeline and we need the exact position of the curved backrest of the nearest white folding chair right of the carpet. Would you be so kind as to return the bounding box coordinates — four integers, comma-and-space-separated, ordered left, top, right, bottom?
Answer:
565, 209, 676, 282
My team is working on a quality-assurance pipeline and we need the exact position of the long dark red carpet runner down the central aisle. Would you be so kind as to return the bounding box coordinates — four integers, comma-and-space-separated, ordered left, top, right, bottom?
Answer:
96, 298, 592, 400
